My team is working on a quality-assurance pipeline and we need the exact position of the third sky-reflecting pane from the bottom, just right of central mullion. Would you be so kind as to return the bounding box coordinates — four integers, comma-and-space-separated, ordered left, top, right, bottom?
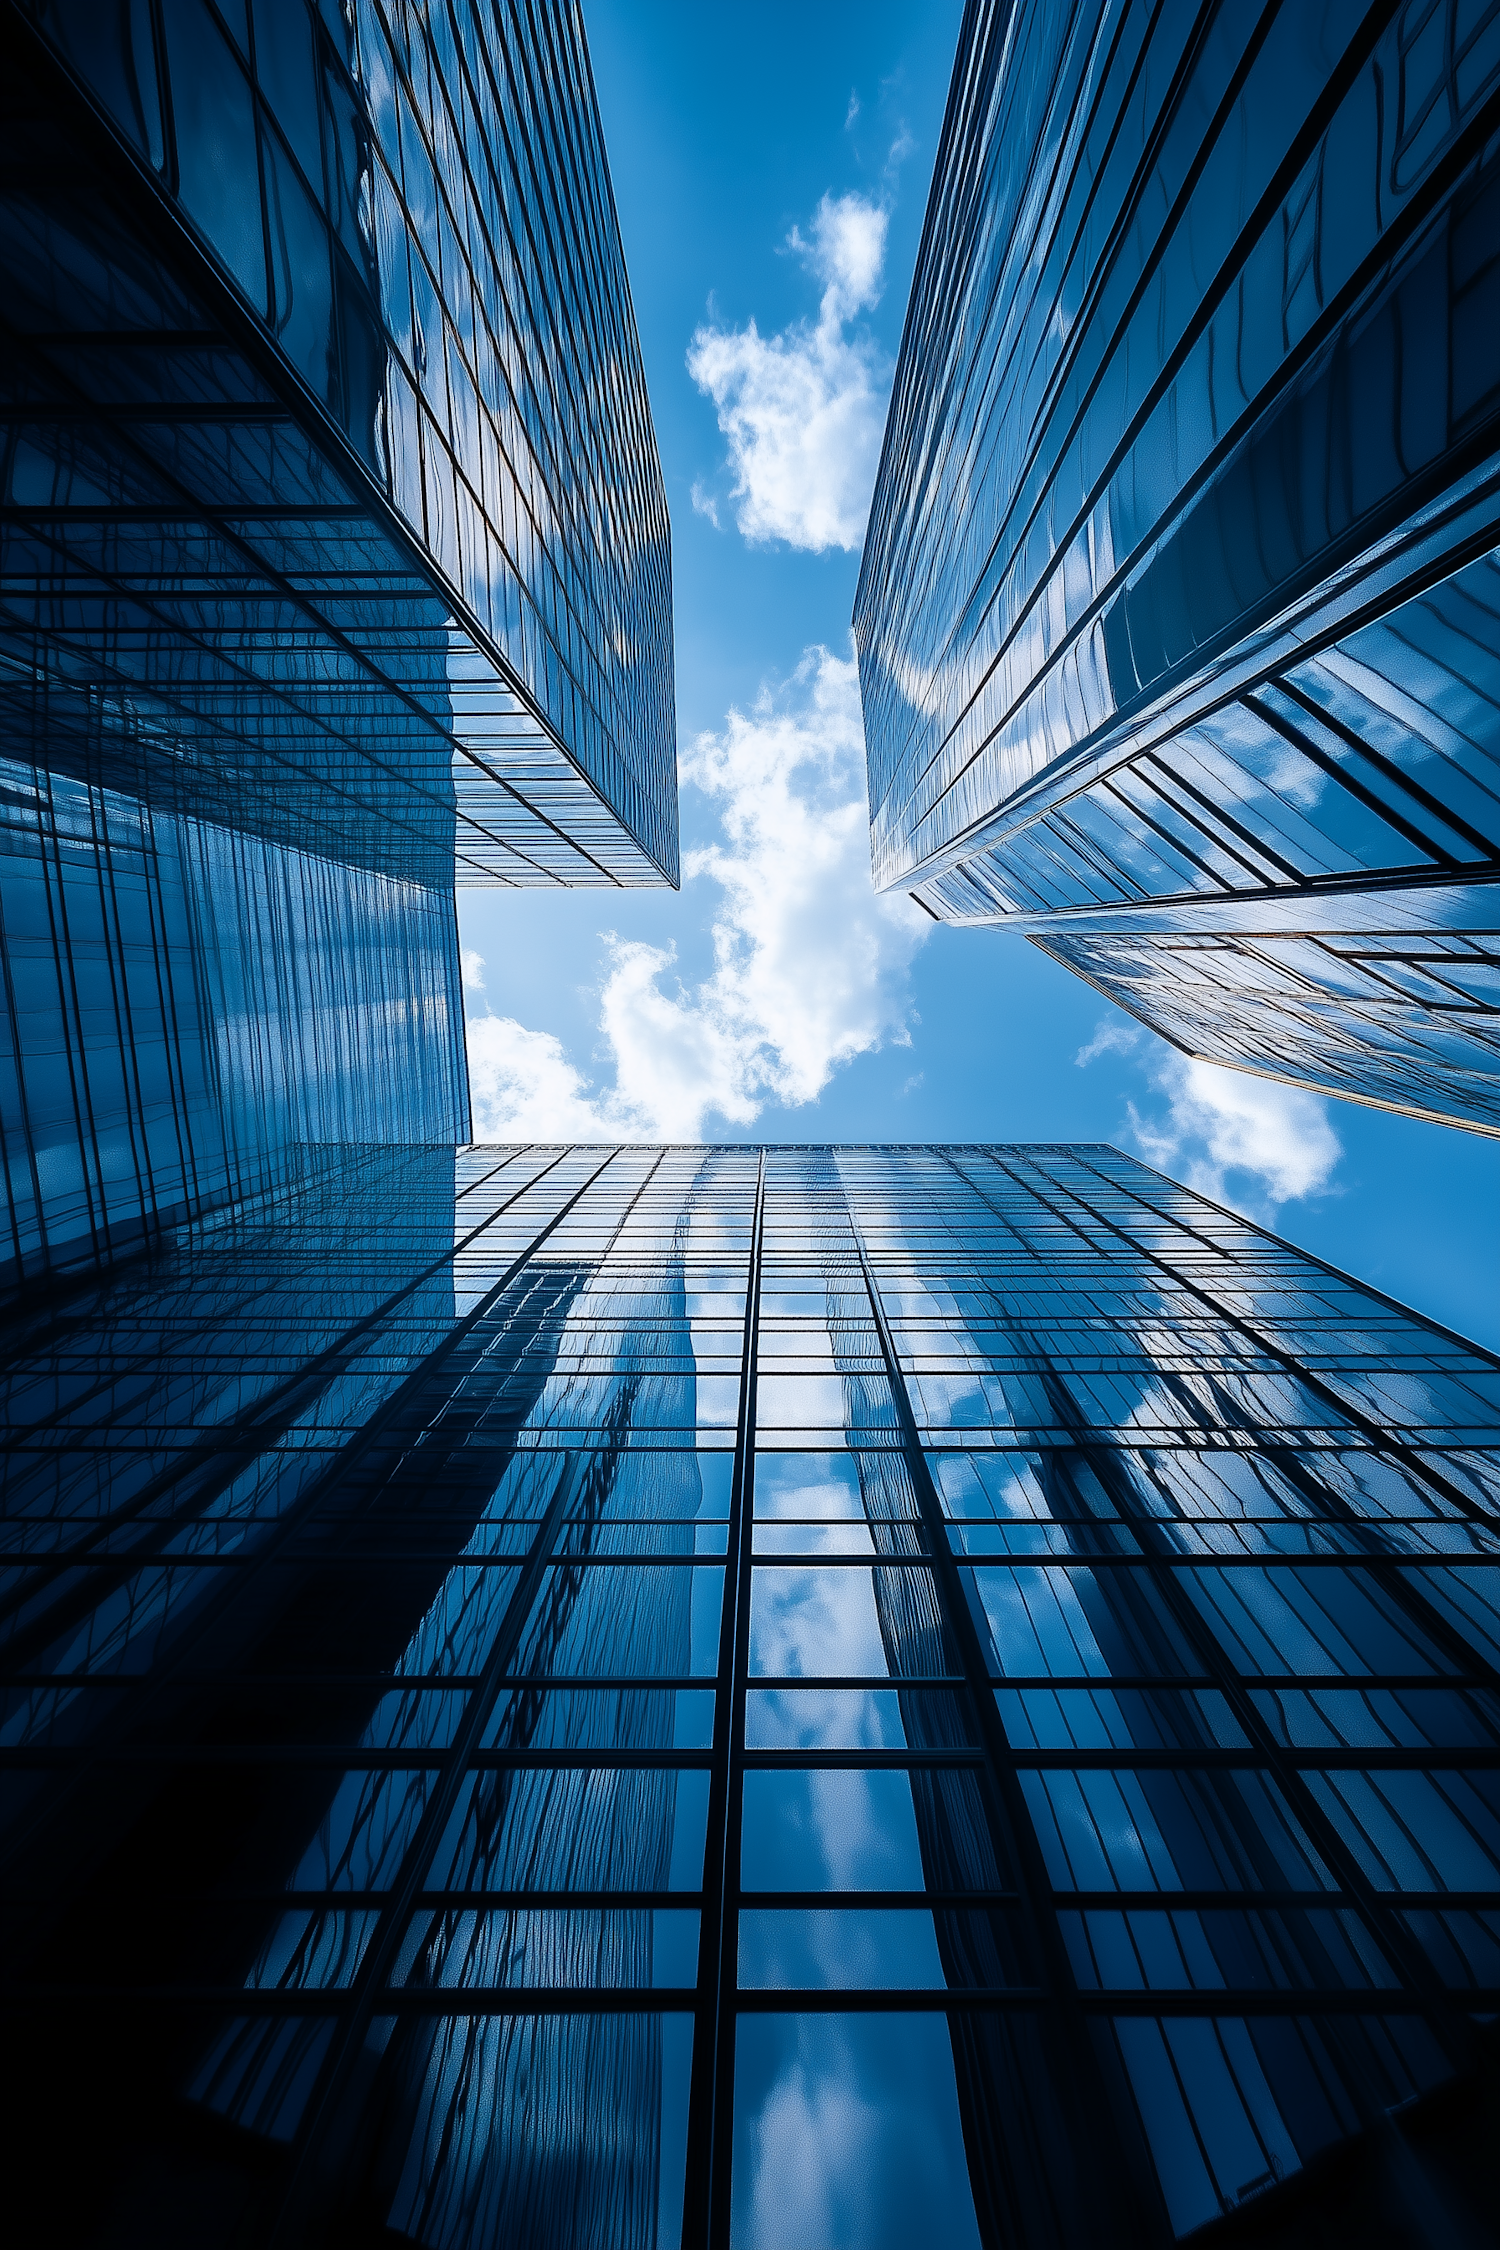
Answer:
740, 1771, 924, 1890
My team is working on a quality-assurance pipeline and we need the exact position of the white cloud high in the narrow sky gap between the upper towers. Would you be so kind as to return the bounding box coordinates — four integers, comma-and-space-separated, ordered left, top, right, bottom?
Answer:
688, 194, 891, 554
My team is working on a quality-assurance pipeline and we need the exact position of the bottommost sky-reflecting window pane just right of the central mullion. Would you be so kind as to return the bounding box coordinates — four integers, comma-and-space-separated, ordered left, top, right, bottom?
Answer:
731, 2016, 978, 2250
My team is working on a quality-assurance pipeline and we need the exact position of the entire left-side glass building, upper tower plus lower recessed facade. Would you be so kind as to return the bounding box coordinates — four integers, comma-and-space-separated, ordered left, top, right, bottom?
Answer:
0, 0, 677, 1278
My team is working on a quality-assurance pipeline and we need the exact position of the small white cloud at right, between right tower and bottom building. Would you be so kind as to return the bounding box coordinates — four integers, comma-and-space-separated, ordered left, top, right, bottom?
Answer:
1127, 1051, 1343, 1206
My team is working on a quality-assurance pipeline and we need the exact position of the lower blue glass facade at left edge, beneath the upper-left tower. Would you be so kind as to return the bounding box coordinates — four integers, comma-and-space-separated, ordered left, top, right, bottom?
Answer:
0, 758, 468, 1289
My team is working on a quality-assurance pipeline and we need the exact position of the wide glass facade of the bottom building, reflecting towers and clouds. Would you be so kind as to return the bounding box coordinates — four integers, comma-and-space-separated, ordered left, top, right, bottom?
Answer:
0, 1148, 1500, 2250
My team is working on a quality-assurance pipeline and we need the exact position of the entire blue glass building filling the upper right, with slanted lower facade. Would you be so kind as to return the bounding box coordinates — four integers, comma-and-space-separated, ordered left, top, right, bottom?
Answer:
855, 0, 1500, 1132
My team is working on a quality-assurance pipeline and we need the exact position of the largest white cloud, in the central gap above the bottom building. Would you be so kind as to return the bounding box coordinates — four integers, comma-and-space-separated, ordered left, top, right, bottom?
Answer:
468, 648, 933, 1141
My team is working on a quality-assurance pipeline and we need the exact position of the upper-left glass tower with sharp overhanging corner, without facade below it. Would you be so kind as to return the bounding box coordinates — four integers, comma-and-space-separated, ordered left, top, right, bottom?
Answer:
4, 0, 677, 887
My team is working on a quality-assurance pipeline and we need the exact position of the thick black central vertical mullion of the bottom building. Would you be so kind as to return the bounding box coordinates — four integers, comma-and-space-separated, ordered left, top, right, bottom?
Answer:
681, 1148, 765, 2250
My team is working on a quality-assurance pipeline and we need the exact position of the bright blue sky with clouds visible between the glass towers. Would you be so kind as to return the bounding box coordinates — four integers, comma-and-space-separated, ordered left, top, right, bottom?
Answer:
459, 0, 1500, 1346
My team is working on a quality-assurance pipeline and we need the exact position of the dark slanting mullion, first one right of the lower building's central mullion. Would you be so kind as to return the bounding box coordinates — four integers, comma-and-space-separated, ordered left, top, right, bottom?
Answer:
846, 1188, 1172, 2241
